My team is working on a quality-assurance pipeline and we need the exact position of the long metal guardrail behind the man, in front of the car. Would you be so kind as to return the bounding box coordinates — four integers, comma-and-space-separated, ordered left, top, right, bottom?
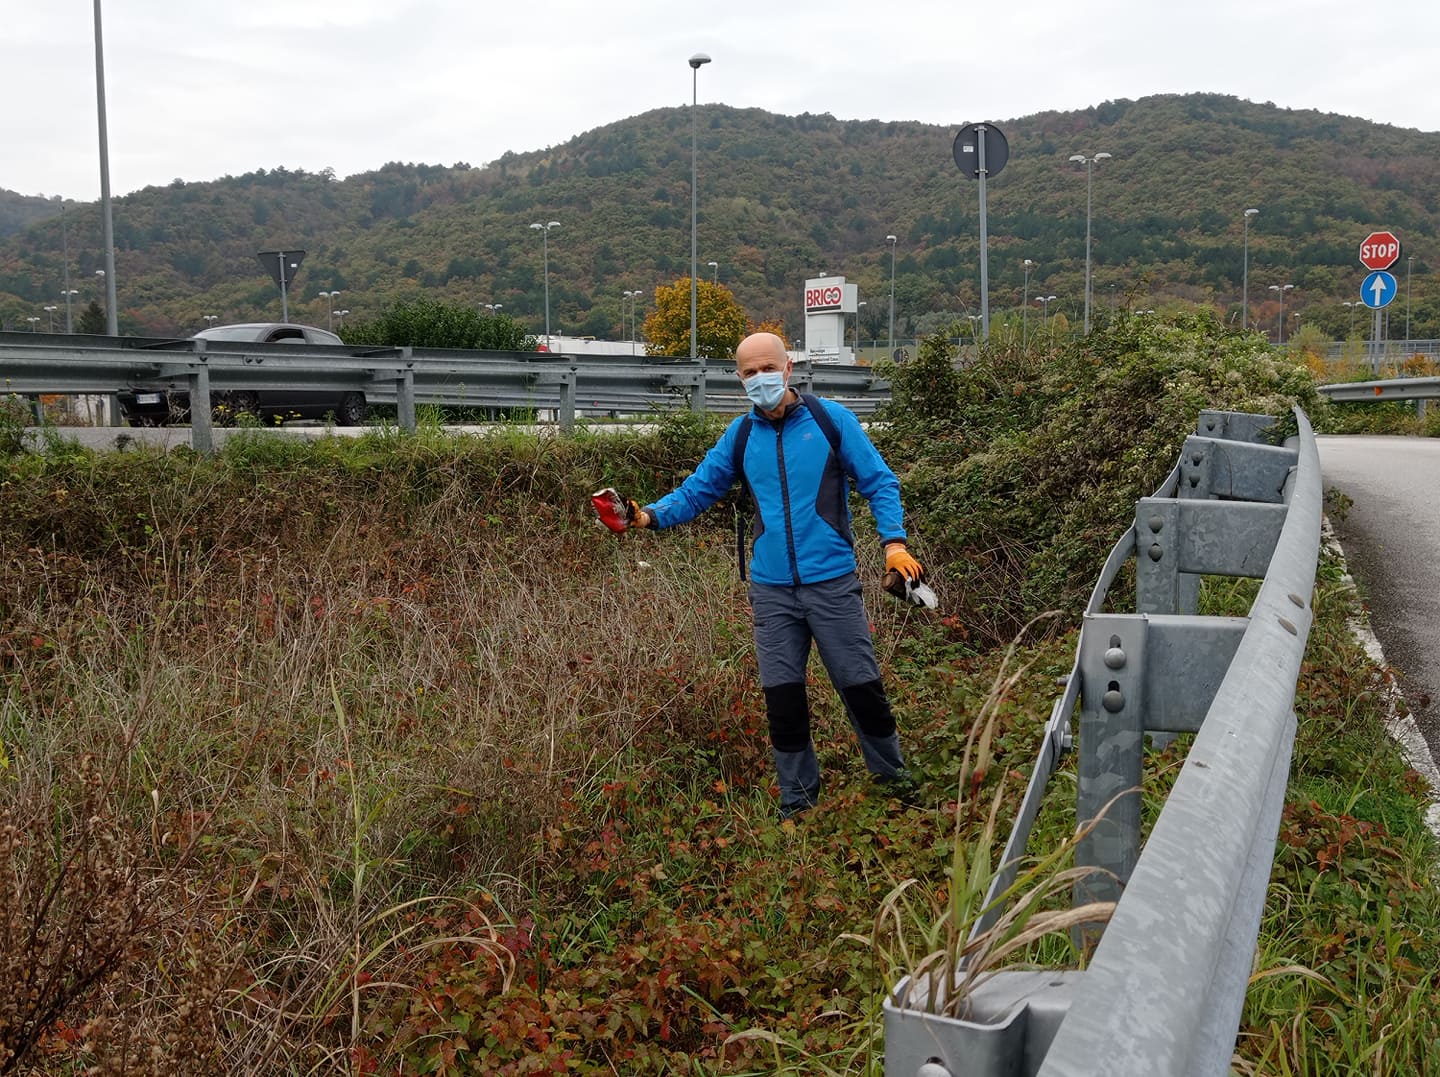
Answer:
0, 333, 890, 452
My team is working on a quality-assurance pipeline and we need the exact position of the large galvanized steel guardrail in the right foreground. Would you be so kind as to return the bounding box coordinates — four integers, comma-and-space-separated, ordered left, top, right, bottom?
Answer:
884, 409, 1320, 1077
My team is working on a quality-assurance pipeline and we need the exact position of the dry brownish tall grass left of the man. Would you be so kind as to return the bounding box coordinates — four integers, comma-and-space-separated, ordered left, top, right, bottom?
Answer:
0, 429, 777, 1073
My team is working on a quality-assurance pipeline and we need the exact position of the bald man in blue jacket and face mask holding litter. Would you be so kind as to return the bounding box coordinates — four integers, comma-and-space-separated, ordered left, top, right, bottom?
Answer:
632, 333, 924, 819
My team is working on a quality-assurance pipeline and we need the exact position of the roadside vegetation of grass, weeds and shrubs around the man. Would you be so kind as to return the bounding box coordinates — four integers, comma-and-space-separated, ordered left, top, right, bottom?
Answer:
0, 317, 1440, 1074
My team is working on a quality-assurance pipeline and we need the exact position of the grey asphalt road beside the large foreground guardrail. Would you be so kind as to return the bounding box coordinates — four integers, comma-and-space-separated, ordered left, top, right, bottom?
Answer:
1316, 436, 1440, 757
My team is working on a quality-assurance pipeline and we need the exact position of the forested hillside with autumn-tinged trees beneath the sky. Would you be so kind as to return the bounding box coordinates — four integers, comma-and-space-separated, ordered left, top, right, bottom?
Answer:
0, 95, 1440, 337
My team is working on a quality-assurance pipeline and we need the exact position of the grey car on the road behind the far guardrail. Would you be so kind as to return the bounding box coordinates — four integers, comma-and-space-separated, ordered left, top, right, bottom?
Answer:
120, 321, 366, 426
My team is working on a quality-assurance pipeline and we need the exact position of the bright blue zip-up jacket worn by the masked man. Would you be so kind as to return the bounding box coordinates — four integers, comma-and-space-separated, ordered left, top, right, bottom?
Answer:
645, 400, 906, 587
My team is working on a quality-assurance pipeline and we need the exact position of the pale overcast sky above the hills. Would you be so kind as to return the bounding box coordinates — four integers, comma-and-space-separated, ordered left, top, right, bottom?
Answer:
11, 0, 1440, 200
